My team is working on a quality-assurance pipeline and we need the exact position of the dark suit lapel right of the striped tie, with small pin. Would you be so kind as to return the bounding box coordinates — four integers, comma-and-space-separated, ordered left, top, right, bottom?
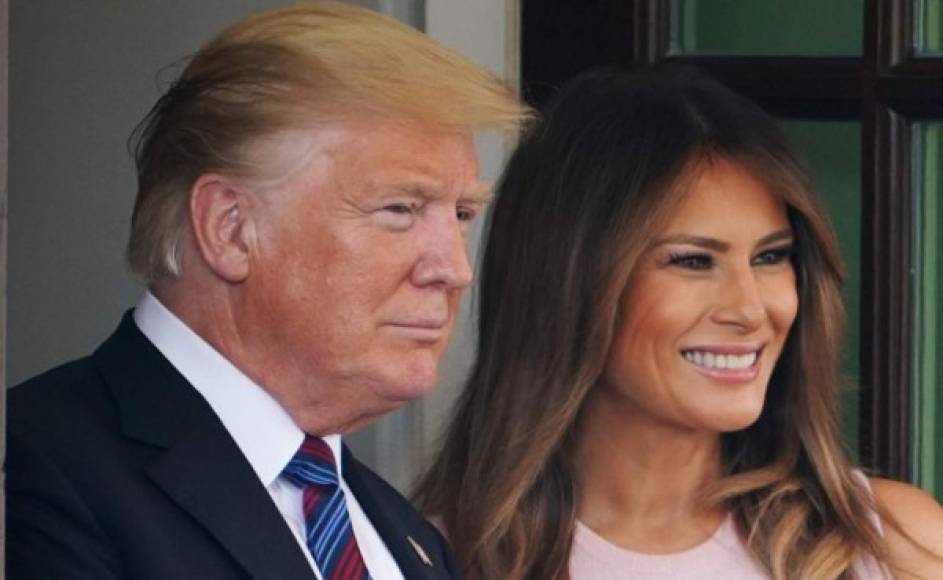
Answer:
343, 446, 442, 580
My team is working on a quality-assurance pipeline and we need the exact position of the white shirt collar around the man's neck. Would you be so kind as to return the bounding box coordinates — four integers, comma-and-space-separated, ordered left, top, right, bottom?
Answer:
134, 292, 341, 487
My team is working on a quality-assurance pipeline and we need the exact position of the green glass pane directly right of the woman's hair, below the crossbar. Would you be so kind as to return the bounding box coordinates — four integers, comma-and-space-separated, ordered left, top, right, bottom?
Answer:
783, 121, 861, 461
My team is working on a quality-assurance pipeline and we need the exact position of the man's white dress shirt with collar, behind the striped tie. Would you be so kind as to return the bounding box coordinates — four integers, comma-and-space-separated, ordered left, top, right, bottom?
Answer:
134, 292, 403, 580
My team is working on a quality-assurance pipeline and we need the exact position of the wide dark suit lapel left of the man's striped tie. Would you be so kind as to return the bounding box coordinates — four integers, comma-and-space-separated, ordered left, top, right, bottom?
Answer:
95, 312, 315, 580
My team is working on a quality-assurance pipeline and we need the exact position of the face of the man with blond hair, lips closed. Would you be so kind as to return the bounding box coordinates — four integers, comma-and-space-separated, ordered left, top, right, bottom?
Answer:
237, 122, 487, 431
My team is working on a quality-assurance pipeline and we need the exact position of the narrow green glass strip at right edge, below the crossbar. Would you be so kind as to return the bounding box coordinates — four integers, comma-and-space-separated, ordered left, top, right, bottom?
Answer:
913, 123, 943, 500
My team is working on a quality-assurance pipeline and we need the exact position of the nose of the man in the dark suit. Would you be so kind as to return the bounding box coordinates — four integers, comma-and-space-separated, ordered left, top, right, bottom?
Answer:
412, 219, 473, 290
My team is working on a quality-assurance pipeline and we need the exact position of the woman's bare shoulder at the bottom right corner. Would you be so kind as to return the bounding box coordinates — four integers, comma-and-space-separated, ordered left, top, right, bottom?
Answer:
868, 477, 943, 578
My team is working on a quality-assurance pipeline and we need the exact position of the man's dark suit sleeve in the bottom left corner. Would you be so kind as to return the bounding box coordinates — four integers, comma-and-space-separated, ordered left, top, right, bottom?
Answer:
5, 433, 123, 580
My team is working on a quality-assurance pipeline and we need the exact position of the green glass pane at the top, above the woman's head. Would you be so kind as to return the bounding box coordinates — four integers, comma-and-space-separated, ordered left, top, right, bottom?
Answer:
671, 0, 868, 56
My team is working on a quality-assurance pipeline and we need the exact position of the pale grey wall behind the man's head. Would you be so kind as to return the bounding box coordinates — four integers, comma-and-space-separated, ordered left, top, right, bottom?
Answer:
7, 0, 507, 489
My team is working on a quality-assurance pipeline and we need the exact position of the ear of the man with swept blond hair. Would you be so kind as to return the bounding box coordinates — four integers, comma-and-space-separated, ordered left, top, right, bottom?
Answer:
190, 173, 253, 283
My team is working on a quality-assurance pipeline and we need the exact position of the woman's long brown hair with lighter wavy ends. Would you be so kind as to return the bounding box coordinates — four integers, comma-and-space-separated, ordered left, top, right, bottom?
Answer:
416, 71, 884, 580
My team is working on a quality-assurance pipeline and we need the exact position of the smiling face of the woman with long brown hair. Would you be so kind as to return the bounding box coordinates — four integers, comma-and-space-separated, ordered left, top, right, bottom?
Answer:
598, 160, 798, 433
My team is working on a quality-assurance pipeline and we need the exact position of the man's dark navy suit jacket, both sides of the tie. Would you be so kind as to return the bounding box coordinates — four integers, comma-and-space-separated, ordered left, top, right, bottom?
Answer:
5, 312, 458, 580
